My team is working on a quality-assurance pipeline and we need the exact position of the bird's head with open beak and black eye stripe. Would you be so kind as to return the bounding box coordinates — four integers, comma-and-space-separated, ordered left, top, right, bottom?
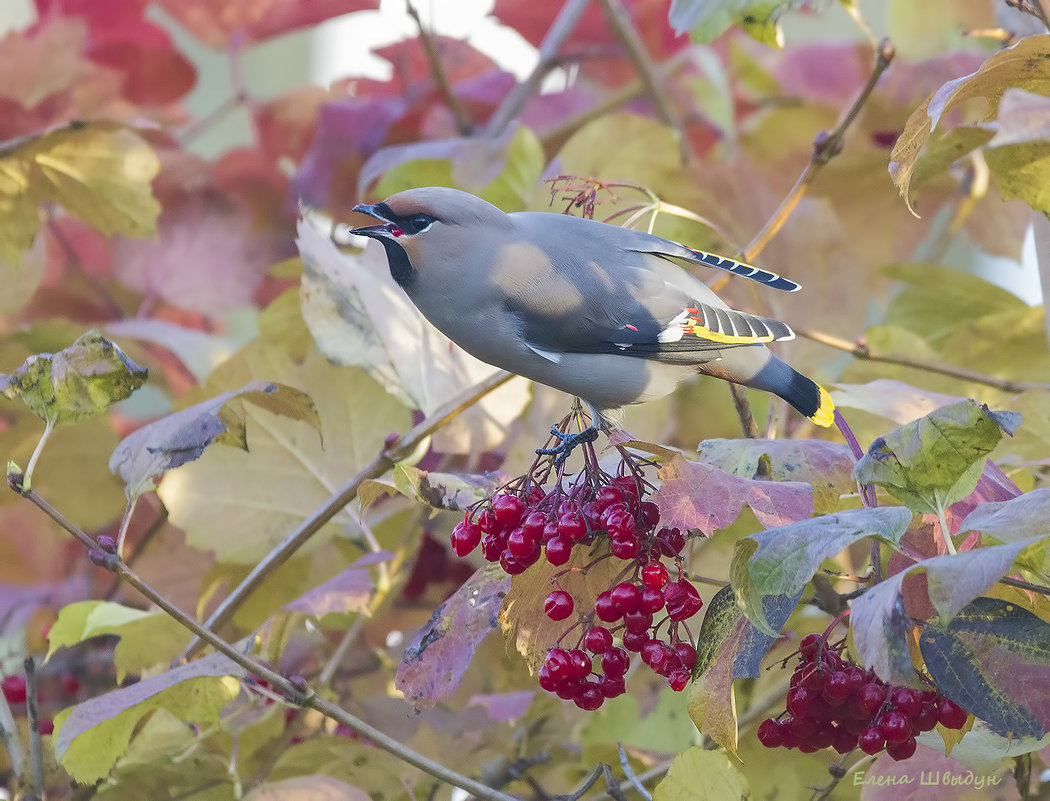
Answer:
351, 187, 509, 288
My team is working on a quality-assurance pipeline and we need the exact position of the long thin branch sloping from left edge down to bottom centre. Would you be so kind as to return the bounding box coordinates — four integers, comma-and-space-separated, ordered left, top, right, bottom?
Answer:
7, 476, 519, 801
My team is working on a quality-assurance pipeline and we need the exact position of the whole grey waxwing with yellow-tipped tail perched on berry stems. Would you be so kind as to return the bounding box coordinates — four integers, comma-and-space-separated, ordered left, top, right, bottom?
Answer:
351, 187, 835, 459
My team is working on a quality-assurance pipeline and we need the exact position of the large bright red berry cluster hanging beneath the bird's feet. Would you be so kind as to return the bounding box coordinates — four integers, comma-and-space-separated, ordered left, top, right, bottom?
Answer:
452, 434, 704, 710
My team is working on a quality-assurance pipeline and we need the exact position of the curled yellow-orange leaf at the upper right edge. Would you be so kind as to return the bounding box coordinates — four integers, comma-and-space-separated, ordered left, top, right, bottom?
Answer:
889, 35, 1050, 214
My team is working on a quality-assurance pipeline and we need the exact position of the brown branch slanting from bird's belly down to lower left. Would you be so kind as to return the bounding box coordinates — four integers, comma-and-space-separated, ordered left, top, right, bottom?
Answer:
181, 371, 511, 659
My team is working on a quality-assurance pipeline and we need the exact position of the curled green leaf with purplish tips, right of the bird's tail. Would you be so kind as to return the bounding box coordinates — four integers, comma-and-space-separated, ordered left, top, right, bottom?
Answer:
854, 400, 1021, 513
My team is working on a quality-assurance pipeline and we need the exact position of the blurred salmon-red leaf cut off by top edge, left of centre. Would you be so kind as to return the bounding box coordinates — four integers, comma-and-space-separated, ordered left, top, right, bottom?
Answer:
153, 0, 379, 49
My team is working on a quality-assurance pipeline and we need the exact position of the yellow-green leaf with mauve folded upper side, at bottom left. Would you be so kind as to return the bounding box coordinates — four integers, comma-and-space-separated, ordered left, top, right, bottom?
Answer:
53, 654, 244, 784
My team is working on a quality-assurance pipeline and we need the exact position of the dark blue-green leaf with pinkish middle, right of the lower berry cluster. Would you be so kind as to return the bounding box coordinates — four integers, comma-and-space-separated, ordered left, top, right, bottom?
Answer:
919, 598, 1050, 737
